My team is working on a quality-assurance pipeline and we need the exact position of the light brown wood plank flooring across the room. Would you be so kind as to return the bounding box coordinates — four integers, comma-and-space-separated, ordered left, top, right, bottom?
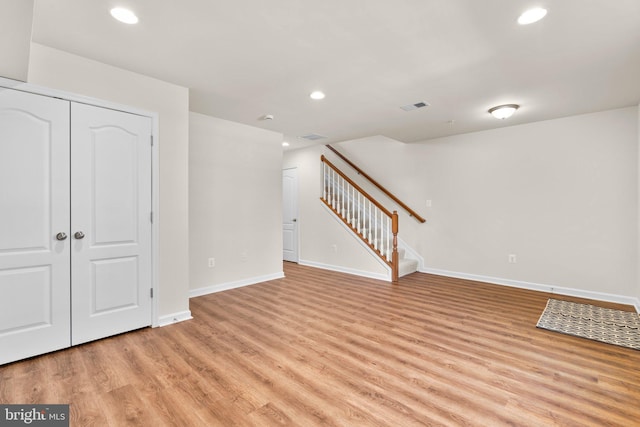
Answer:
0, 263, 640, 426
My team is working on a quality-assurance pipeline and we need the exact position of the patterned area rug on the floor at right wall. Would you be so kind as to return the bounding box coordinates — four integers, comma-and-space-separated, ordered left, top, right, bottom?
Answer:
536, 299, 640, 350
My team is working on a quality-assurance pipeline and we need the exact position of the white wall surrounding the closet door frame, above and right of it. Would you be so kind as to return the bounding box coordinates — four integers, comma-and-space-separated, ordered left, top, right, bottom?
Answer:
28, 43, 189, 317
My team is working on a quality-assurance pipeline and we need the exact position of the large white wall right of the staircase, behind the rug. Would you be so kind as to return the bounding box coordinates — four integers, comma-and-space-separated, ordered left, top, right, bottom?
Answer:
294, 107, 639, 299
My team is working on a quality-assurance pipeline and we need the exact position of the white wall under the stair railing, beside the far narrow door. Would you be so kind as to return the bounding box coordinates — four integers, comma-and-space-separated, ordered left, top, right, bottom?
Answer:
283, 146, 387, 278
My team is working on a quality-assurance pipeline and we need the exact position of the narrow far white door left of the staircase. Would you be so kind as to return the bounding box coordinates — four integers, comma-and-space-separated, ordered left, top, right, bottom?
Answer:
282, 168, 298, 262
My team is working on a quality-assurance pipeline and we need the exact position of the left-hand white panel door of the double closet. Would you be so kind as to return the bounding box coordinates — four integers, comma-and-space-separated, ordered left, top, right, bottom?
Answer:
0, 88, 71, 364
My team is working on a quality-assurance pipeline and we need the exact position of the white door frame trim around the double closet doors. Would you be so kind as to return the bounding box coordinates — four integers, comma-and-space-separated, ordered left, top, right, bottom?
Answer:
0, 77, 160, 328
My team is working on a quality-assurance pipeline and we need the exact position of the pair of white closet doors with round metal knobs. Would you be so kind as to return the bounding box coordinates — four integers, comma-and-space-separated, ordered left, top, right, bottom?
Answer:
0, 88, 152, 364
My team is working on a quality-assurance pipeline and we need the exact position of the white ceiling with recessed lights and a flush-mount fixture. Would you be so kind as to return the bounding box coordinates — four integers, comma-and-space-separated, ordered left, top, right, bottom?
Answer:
32, 0, 640, 148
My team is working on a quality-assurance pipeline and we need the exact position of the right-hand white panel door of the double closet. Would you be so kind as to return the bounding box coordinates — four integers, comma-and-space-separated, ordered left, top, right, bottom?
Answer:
70, 104, 151, 345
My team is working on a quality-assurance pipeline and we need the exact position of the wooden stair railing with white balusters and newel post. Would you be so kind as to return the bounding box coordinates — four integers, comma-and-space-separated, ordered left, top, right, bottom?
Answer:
320, 156, 400, 283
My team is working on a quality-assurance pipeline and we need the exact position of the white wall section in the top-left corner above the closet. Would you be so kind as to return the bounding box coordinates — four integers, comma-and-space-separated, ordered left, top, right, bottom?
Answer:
0, 0, 33, 82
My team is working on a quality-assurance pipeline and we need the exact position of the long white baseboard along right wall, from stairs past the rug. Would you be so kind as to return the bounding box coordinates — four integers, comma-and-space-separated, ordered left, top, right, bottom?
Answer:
420, 268, 640, 313
